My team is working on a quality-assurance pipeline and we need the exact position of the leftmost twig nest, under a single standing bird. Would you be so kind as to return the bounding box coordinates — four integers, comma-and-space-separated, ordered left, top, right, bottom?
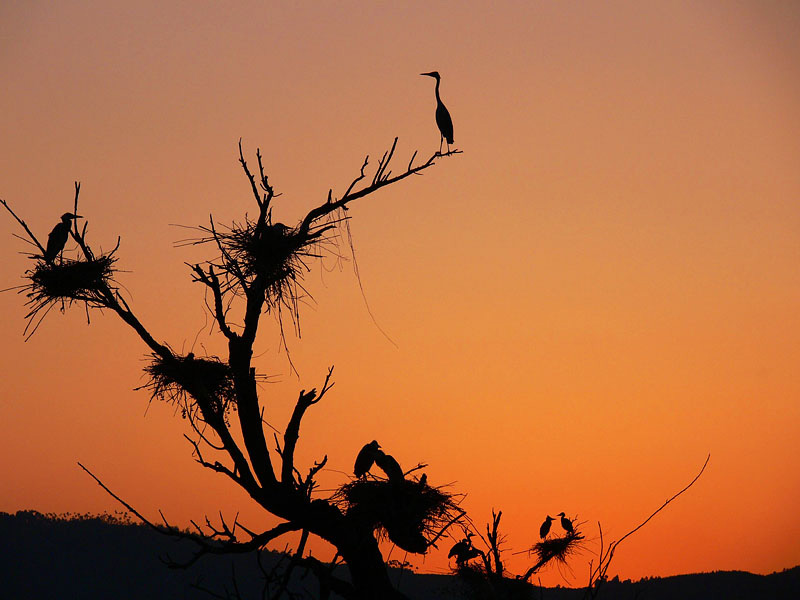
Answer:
19, 251, 117, 335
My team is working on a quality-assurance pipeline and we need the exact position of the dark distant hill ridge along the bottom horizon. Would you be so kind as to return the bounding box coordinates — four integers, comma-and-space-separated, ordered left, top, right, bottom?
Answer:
0, 511, 800, 600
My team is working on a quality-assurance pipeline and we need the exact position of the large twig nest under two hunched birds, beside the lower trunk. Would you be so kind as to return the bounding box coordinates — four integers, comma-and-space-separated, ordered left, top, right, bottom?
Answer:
334, 479, 461, 554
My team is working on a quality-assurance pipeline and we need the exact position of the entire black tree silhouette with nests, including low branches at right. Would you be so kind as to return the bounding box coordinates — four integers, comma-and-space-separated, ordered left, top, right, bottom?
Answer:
0, 130, 708, 599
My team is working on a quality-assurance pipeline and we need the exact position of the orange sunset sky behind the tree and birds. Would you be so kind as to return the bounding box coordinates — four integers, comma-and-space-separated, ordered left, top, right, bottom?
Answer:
0, 1, 800, 585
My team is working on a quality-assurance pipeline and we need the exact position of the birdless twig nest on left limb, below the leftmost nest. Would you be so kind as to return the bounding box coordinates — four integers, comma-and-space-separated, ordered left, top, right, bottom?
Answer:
140, 353, 236, 421
